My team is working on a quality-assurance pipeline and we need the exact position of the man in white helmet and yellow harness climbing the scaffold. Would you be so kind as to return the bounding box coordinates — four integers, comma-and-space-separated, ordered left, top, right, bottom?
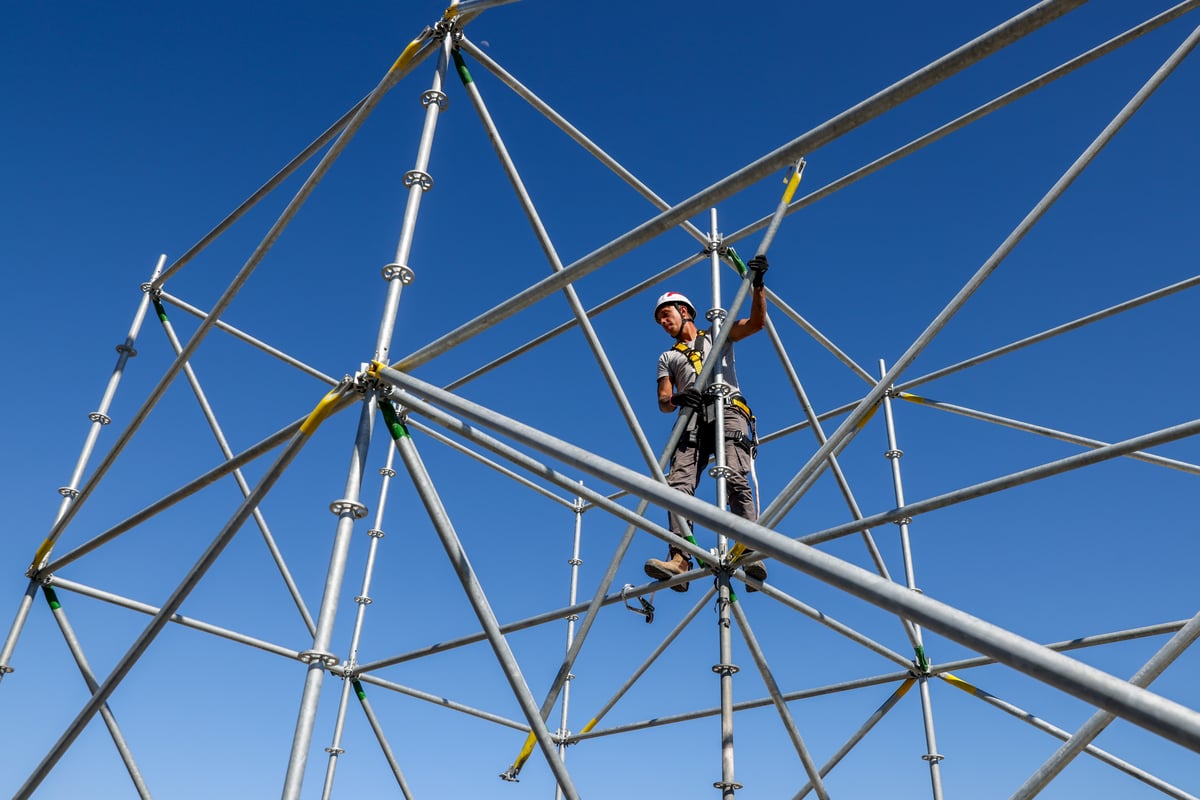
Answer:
646, 255, 767, 591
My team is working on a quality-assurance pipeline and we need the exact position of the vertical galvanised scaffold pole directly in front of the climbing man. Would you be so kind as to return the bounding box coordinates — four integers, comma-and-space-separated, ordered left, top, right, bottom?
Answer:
697, 209, 742, 800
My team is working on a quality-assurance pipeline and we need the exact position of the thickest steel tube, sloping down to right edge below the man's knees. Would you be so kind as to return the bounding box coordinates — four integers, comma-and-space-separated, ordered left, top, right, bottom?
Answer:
380, 368, 1200, 750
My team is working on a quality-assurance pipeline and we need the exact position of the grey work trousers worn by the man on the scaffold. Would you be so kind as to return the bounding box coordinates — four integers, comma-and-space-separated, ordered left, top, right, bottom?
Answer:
667, 405, 758, 539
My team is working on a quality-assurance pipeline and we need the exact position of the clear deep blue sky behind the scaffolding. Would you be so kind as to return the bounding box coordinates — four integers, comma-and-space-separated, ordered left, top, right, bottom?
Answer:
0, 0, 1200, 800
